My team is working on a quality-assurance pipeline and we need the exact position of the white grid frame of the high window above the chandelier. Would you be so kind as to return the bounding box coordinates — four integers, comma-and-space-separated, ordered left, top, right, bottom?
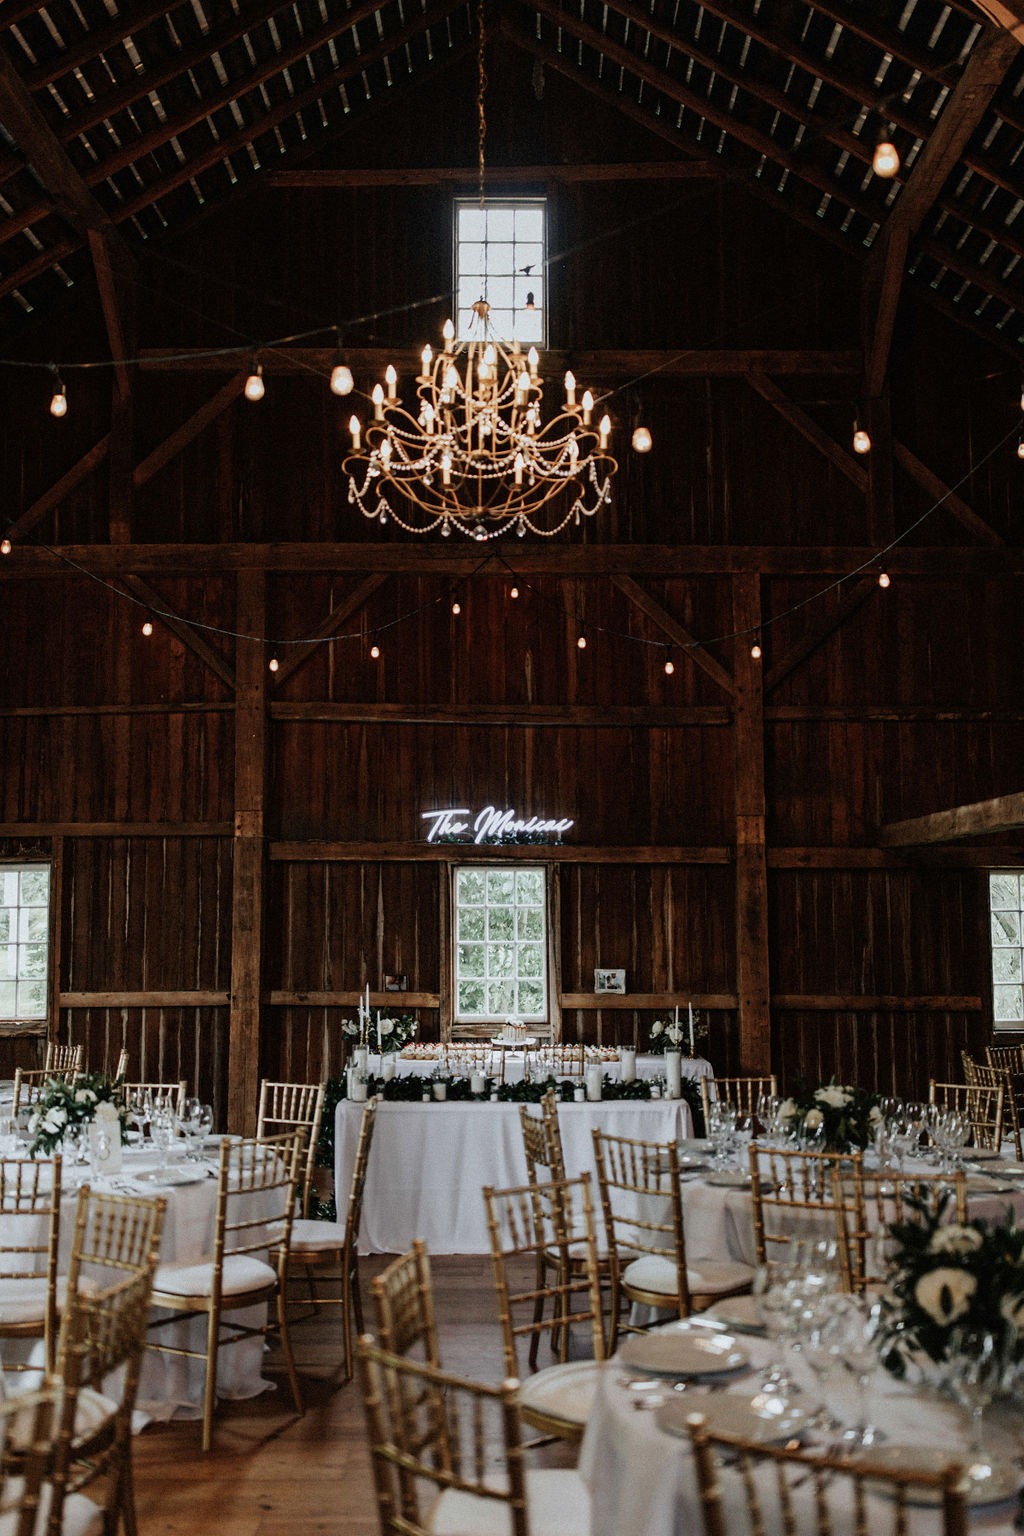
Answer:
451, 197, 548, 349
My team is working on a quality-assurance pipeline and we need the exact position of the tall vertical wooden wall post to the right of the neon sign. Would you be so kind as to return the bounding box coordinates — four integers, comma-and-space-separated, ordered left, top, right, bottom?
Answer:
732, 573, 772, 1075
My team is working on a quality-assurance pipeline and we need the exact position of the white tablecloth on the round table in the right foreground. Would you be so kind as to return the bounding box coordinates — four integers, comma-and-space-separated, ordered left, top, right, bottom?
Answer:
579, 1336, 1024, 1536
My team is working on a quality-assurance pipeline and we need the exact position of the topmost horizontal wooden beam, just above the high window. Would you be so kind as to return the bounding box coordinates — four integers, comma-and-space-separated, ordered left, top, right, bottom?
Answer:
268, 160, 728, 190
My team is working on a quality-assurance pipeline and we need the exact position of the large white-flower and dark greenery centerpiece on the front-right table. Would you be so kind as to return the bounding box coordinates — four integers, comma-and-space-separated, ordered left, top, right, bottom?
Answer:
881, 1210, 1024, 1376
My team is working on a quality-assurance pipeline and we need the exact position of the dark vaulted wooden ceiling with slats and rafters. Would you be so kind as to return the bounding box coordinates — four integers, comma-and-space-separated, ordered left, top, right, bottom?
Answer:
0, 0, 1024, 377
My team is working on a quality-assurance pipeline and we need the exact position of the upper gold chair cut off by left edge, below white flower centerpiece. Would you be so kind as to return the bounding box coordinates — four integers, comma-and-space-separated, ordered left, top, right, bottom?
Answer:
0, 1154, 61, 1370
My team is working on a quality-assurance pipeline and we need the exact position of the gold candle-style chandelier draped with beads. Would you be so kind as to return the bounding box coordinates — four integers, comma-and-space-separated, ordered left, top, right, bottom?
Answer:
342, 298, 617, 541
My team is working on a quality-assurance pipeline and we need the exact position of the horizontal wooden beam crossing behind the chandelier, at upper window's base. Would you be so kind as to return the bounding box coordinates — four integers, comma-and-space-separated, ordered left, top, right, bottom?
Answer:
140, 347, 861, 381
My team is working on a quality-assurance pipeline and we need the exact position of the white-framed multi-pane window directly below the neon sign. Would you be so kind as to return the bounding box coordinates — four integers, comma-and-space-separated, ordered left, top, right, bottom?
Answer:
453, 865, 548, 1025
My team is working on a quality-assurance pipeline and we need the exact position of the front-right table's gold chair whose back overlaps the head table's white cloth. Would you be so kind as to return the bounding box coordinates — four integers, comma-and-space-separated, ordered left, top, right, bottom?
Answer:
484, 1174, 605, 1441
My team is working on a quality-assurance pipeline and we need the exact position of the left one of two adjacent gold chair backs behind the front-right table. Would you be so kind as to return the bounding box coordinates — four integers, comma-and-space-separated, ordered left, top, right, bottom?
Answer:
749, 1141, 861, 1267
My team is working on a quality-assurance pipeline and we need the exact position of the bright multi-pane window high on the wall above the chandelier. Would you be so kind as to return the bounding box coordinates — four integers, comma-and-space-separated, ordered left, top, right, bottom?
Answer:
454, 198, 547, 347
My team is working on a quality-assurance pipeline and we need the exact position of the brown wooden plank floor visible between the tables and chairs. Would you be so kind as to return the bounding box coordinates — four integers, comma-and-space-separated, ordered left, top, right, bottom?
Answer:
134, 1258, 576, 1536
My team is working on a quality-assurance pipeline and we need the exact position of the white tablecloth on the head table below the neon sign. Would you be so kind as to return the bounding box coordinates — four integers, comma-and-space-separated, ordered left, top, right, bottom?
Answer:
335, 1098, 692, 1253
